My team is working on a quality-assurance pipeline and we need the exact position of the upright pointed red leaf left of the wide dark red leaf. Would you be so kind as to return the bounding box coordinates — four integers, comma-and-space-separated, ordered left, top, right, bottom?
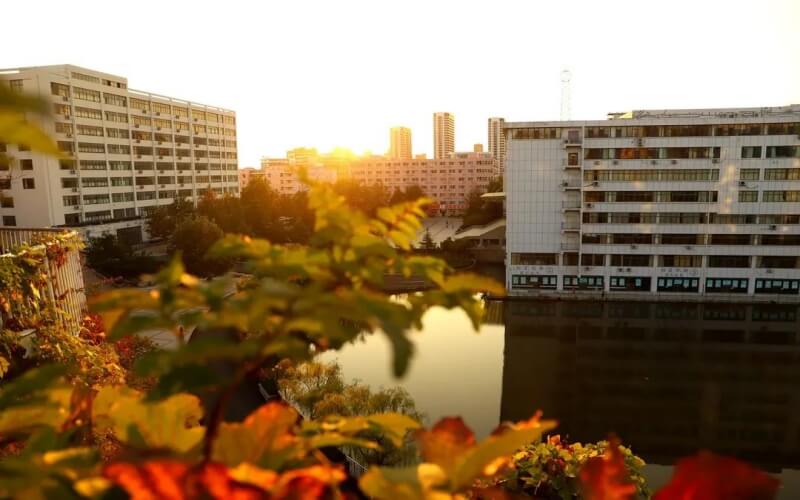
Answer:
580, 437, 636, 500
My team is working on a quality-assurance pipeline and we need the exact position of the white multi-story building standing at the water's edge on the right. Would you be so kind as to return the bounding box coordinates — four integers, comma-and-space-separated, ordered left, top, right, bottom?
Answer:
505, 105, 800, 301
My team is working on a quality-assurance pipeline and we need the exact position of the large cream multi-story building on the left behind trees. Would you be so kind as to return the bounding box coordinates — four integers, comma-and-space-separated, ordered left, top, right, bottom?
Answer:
0, 65, 239, 241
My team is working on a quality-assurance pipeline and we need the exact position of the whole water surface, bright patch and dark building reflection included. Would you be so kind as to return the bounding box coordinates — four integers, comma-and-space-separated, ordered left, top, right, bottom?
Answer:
325, 301, 800, 498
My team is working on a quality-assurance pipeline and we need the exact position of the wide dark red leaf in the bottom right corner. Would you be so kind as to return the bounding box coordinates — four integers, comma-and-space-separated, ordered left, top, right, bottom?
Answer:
653, 452, 779, 500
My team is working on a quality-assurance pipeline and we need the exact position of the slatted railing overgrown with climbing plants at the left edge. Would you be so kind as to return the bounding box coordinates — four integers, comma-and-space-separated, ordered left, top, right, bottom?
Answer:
0, 228, 86, 327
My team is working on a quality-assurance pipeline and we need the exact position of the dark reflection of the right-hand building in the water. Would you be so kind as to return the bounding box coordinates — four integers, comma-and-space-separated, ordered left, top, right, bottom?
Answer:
500, 301, 800, 471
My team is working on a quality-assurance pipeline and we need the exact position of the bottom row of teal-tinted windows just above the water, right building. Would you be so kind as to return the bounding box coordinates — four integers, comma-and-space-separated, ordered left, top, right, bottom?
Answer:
511, 274, 800, 295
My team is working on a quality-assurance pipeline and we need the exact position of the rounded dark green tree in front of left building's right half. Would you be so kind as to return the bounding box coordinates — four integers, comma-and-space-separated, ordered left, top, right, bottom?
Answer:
169, 216, 231, 277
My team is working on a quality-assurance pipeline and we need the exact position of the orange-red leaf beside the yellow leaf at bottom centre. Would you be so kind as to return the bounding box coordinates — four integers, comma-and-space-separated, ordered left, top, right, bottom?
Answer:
415, 417, 475, 470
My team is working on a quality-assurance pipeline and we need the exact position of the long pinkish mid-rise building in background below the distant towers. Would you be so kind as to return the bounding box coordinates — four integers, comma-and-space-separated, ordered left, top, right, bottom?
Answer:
350, 152, 496, 215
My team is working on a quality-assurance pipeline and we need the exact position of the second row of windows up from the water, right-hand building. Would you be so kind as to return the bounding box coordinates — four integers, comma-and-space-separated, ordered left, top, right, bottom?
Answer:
511, 253, 800, 269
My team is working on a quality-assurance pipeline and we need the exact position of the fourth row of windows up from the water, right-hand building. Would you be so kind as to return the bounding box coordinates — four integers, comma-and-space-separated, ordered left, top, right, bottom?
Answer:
582, 212, 800, 224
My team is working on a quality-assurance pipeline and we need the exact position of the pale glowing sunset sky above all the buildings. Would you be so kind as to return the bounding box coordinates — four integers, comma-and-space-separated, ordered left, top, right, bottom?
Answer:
0, 0, 800, 166
